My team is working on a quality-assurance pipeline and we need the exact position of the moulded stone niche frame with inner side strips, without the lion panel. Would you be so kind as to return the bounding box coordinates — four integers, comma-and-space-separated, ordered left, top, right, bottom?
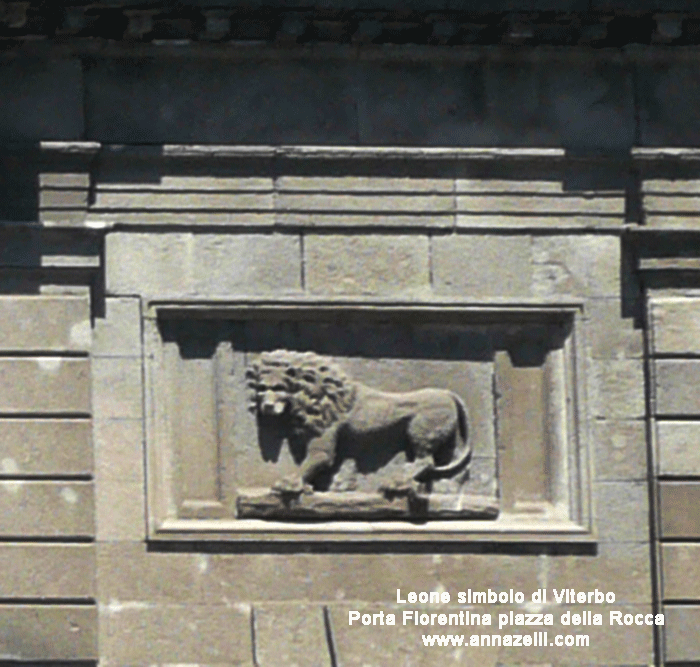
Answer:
143, 300, 595, 542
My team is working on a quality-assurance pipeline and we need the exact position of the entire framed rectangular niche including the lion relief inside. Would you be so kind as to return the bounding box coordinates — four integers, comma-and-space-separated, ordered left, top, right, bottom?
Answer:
145, 304, 589, 539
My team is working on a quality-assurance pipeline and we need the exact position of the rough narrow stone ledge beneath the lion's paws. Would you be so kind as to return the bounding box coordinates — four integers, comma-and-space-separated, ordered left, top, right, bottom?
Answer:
237, 489, 499, 521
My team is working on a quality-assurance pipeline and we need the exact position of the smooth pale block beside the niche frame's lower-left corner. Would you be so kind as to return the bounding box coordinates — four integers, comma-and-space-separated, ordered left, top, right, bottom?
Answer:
95, 478, 146, 542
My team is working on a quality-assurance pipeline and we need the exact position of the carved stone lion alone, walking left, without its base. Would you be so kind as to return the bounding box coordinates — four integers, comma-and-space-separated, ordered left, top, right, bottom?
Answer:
246, 350, 471, 494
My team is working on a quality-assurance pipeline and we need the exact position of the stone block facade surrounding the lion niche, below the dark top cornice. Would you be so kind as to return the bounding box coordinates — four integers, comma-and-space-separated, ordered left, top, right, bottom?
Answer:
0, 40, 700, 667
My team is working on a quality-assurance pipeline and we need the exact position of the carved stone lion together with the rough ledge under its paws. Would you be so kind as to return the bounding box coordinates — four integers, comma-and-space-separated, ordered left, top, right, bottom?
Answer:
238, 350, 498, 518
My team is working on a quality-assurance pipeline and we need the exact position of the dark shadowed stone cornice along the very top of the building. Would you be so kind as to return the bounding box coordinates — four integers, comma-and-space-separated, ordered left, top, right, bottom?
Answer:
0, 0, 700, 47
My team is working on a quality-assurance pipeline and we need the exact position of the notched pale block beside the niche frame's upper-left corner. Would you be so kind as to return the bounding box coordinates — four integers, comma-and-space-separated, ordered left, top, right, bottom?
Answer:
92, 298, 141, 357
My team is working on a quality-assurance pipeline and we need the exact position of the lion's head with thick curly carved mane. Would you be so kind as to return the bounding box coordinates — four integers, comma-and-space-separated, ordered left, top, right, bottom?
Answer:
246, 350, 355, 436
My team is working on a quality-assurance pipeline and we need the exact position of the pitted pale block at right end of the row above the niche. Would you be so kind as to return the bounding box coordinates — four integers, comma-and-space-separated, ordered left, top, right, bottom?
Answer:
532, 236, 621, 298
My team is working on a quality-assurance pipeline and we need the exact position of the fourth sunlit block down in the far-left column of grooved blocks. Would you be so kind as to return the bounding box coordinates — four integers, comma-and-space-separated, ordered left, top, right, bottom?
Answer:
0, 480, 95, 538
